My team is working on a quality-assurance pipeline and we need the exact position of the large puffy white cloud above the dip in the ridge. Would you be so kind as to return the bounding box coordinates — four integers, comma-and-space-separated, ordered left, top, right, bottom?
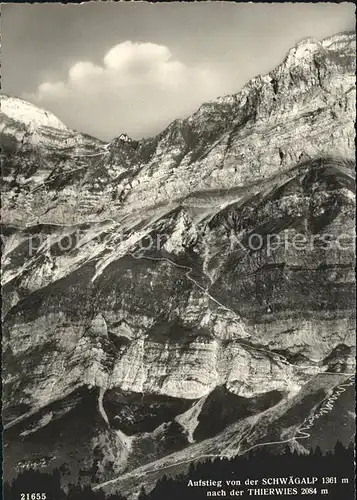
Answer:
26, 41, 229, 139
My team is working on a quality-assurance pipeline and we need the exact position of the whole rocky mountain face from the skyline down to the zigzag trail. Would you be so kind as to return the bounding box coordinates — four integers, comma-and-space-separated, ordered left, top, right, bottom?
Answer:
1, 34, 355, 494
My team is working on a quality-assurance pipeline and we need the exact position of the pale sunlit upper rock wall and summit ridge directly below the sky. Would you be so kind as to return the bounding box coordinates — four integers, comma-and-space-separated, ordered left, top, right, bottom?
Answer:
1, 33, 356, 226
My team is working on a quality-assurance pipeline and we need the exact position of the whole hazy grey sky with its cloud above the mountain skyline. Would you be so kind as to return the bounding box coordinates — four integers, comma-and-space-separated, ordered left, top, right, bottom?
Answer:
1, 2, 355, 140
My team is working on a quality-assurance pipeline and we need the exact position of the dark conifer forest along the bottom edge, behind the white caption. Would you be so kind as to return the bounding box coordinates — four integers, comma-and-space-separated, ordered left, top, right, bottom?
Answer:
4, 442, 355, 500
